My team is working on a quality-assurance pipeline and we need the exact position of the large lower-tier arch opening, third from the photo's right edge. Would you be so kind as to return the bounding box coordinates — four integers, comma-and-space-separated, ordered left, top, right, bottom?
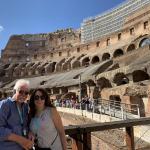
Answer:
97, 77, 112, 90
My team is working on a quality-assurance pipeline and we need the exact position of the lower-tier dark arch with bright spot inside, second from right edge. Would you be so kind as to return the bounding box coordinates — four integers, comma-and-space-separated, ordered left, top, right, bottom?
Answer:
113, 73, 129, 86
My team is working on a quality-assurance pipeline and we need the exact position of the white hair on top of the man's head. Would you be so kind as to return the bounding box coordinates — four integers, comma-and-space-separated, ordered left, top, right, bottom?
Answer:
14, 79, 30, 90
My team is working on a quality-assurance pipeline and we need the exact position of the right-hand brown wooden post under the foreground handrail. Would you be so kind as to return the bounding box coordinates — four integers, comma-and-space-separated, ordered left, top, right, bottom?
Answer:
126, 127, 135, 150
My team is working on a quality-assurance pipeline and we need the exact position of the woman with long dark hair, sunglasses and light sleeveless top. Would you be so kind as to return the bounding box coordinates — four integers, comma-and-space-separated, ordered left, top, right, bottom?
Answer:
29, 89, 66, 150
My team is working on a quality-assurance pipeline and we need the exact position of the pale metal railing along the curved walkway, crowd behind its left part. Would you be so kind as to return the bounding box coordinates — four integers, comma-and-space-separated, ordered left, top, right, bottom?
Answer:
55, 99, 140, 120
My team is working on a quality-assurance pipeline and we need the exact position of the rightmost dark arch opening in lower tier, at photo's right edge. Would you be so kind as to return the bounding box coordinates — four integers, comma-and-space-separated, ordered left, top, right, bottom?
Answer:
132, 70, 149, 82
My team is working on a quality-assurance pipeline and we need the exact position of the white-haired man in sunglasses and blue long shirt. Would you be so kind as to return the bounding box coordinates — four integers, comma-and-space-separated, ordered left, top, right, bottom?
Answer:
0, 79, 33, 150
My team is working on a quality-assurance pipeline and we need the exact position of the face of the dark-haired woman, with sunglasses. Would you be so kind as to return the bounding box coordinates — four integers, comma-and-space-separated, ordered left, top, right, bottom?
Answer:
34, 91, 45, 109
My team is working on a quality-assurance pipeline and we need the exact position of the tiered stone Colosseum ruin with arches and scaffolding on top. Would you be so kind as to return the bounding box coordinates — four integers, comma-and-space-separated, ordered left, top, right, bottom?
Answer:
0, 0, 150, 116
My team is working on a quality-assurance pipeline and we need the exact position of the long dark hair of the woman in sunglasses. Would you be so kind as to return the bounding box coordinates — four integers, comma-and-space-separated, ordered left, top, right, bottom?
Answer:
29, 88, 54, 119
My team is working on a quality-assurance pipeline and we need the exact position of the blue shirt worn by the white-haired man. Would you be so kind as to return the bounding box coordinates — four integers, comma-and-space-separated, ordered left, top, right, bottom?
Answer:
0, 98, 28, 150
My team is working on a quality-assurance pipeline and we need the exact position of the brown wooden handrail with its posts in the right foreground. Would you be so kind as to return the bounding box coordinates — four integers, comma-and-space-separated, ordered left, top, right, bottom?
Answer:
65, 117, 150, 150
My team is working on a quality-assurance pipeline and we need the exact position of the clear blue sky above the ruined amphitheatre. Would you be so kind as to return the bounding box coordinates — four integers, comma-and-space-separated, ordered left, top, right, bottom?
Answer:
0, 0, 125, 50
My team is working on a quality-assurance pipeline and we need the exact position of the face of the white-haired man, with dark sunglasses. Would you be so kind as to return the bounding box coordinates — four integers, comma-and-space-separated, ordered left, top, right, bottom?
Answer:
15, 86, 29, 103
